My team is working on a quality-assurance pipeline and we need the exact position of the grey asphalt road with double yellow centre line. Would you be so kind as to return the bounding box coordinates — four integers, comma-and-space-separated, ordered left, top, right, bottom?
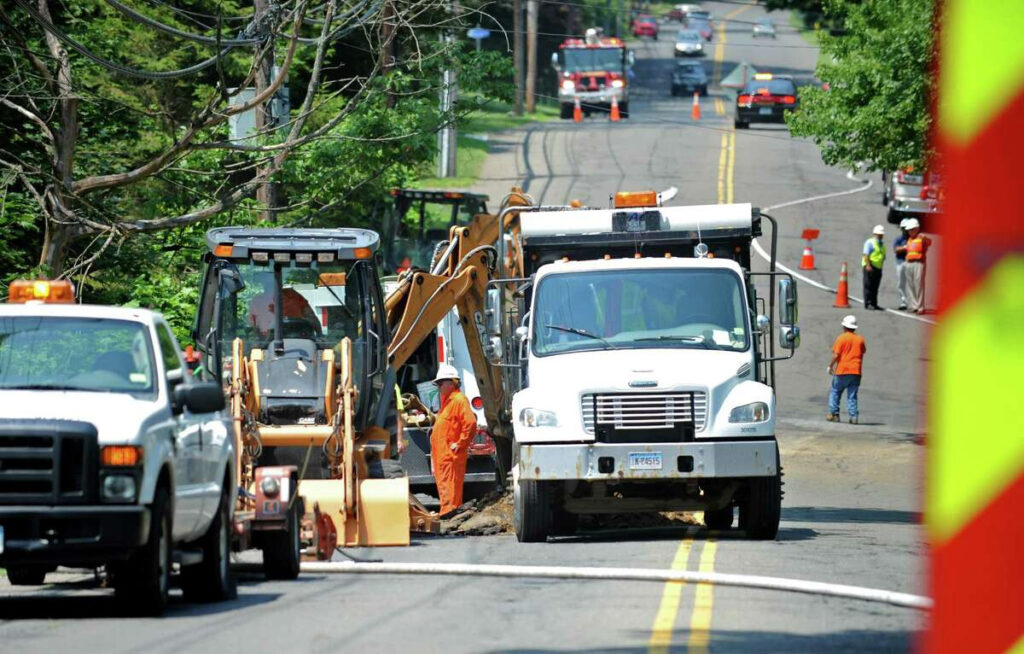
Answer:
0, 3, 927, 654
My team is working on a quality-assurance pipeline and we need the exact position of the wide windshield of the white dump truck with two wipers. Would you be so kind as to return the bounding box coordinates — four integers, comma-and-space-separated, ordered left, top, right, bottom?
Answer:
531, 269, 749, 356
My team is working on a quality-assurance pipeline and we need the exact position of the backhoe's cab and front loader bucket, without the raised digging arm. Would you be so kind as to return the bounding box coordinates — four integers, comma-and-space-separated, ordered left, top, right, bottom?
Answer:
193, 227, 432, 569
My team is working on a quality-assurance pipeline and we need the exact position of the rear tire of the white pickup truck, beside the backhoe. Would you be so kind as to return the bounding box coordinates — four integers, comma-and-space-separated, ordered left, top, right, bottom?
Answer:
181, 487, 238, 602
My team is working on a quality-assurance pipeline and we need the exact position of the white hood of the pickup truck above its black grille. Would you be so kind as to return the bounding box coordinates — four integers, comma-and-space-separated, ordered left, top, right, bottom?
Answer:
0, 390, 162, 442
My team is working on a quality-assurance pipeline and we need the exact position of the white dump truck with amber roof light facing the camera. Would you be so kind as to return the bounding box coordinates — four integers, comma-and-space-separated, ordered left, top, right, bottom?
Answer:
488, 191, 800, 541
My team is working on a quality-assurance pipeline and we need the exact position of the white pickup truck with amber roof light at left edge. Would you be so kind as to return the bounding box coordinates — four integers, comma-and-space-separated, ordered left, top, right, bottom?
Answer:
0, 282, 236, 614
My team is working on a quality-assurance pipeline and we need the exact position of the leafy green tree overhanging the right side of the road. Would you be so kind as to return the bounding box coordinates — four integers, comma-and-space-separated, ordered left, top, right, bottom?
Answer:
787, 0, 934, 170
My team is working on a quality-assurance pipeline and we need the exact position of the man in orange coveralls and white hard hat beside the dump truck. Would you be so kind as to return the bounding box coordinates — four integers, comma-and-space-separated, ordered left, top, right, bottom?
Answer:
430, 363, 476, 518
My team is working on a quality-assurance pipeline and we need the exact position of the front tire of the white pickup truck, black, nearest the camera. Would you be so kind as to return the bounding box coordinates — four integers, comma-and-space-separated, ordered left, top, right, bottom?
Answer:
114, 487, 173, 615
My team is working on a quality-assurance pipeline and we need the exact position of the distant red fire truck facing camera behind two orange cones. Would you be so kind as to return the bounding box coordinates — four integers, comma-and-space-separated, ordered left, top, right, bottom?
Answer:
551, 28, 634, 119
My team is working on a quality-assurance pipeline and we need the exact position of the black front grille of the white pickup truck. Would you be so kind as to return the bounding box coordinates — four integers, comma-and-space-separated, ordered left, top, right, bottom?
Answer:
0, 421, 98, 505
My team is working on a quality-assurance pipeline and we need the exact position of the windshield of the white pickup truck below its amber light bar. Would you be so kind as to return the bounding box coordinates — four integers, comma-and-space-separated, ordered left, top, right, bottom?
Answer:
0, 316, 155, 396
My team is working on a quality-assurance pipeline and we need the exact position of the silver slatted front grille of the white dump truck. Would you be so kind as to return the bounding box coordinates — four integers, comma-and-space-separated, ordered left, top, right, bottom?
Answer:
580, 391, 708, 434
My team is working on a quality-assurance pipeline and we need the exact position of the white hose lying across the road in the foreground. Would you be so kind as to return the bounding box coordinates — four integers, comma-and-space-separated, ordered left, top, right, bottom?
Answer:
302, 561, 932, 610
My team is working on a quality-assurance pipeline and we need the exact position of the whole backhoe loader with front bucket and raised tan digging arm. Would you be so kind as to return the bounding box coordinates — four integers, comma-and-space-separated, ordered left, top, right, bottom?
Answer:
191, 190, 530, 564
